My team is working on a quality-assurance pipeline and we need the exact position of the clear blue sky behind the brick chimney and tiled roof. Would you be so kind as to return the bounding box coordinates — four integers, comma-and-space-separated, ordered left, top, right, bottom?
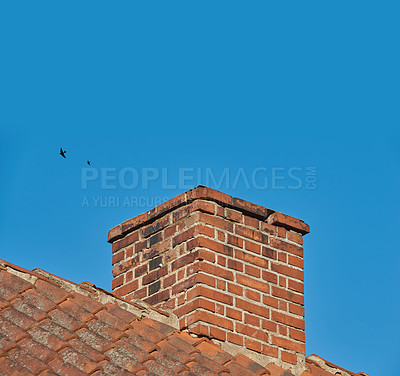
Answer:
0, 1, 400, 376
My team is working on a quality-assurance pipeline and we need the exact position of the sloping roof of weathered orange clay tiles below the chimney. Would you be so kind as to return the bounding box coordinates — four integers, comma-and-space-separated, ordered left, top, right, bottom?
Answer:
0, 260, 364, 376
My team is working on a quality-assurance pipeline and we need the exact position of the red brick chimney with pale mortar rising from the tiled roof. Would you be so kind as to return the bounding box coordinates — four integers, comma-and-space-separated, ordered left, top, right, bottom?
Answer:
108, 186, 309, 374
